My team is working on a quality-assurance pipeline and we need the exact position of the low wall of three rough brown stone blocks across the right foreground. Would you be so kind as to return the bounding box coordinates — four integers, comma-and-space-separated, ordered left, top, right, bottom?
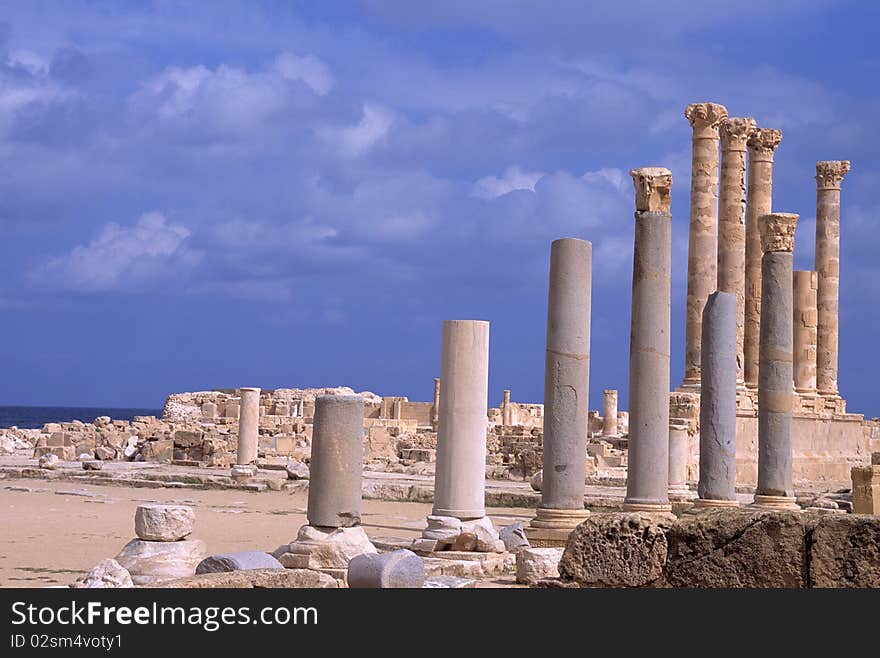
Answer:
552, 508, 880, 588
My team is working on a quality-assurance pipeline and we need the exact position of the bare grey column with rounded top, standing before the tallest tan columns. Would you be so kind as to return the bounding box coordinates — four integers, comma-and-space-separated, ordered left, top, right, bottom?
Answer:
694, 292, 739, 507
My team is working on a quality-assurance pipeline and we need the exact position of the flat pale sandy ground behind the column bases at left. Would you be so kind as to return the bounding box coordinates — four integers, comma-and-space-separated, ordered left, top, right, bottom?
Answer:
0, 479, 534, 587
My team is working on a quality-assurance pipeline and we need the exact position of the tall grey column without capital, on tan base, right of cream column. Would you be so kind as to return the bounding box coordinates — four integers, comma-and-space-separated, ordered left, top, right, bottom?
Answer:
529, 238, 593, 546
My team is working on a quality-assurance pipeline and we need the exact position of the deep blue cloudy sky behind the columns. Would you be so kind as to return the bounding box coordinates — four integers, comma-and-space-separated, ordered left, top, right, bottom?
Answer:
0, 0, 880, 416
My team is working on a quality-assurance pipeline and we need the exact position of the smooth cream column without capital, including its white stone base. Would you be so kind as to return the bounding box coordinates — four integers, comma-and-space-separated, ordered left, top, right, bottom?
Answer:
424, 320, 504, 551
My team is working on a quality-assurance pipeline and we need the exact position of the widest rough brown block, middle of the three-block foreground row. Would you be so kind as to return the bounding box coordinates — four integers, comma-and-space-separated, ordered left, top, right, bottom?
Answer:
666, 509, 807, 588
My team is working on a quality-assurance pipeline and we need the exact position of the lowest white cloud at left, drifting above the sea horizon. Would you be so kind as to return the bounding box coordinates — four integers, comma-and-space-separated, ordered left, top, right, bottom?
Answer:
31, 212, 201, 292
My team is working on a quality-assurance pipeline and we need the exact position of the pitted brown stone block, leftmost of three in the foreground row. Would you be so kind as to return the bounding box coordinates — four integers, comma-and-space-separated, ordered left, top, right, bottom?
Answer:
559, 512, 675, 587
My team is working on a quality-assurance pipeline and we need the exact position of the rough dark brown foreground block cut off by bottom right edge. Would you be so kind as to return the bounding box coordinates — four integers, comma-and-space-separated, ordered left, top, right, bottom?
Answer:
809, 514, 880, 587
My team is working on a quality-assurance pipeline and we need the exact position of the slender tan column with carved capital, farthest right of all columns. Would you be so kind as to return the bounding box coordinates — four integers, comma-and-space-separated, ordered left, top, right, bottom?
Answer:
815, 160, 850, 397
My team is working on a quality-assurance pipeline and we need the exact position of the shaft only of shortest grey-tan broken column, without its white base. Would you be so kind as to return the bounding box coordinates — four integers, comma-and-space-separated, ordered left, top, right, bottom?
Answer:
307, 395, 364, 528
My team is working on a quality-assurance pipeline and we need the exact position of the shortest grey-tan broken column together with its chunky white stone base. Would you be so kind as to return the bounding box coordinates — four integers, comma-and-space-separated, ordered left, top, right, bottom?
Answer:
279, 395, 376, 570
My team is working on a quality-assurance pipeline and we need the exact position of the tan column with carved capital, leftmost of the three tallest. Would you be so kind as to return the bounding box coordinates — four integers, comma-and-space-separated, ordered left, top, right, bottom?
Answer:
682, 103, 727, 388
